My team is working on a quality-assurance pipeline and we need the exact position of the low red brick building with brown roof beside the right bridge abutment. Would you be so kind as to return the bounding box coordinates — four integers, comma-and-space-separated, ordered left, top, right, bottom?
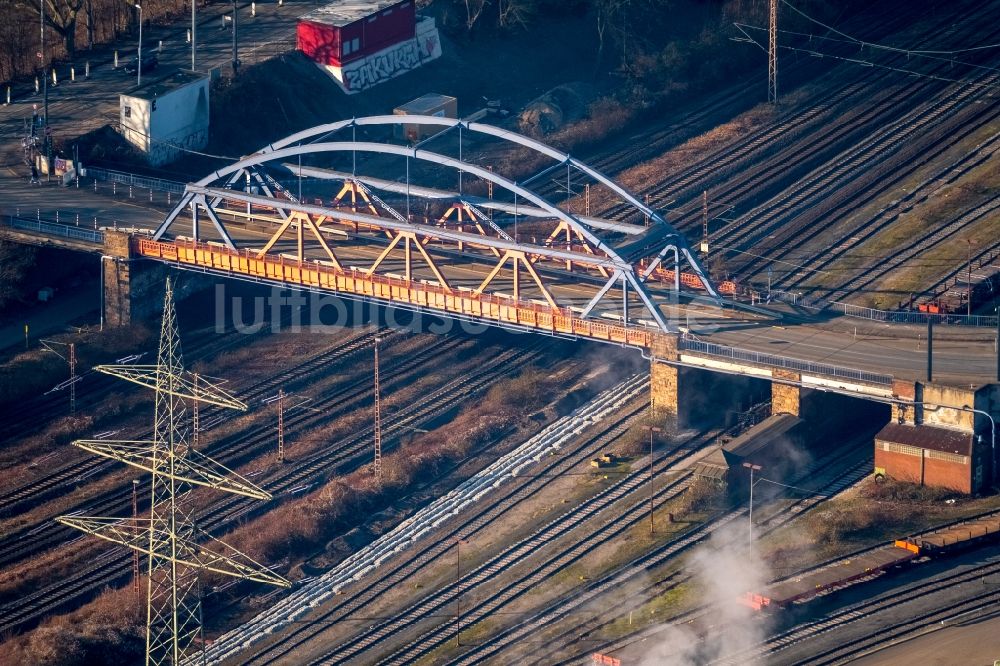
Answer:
875, 423, 989, 494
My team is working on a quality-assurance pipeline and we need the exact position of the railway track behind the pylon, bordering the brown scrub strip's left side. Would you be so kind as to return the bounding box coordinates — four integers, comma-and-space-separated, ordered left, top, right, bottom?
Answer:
0, 334, 541, 631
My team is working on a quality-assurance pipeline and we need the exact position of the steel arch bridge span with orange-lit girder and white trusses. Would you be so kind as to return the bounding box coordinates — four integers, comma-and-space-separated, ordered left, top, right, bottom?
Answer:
145, 115, 726, 346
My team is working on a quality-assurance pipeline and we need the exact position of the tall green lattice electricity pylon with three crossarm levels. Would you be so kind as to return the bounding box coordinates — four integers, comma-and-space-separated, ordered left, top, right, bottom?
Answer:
56, 279, 289, 666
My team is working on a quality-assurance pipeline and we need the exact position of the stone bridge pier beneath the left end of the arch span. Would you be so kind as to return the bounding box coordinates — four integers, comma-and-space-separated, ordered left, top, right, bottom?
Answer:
101, 231, 166, 327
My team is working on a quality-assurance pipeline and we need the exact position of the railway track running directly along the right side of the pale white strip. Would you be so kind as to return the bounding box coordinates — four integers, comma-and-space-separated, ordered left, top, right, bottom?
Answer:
231, 375, 660, 665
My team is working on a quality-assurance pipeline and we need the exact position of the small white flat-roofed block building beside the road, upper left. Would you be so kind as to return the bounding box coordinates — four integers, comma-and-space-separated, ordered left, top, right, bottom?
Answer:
121, 71, 209, 166
